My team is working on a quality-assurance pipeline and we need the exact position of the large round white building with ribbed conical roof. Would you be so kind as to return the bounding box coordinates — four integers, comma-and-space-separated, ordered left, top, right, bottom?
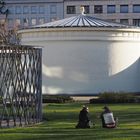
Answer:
19, 14, 140, 95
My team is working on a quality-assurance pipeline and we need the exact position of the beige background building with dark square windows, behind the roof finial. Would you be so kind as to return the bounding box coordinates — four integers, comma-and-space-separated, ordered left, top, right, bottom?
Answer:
64, 0, 140, 26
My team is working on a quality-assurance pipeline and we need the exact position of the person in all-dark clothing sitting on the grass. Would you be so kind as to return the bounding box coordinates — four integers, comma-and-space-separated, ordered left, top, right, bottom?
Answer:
76, 106, 90, 128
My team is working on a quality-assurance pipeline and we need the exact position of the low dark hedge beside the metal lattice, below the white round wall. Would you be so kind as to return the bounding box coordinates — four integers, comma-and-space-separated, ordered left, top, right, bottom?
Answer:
43, 95, 73, 103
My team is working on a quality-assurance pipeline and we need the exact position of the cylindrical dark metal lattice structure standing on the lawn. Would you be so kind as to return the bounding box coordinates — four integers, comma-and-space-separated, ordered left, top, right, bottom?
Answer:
0, 46, 42, 127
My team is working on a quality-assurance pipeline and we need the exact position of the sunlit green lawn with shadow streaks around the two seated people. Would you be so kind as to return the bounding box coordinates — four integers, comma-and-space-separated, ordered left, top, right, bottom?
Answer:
0, 103, 140, 140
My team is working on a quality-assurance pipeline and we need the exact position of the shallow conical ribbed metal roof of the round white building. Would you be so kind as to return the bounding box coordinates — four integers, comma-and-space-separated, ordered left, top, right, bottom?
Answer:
33, 14, 130, 28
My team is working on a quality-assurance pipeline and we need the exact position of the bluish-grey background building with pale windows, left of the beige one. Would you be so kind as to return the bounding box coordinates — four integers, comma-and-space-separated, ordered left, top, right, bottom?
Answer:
0, 0, 64, 27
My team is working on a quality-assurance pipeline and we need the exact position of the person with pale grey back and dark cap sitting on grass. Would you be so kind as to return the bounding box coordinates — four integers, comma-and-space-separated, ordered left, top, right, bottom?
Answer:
100, 106, 117, 128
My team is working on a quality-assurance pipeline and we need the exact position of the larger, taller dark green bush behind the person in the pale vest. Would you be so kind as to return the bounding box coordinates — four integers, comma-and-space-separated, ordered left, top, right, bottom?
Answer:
90, 92, 140, 103
